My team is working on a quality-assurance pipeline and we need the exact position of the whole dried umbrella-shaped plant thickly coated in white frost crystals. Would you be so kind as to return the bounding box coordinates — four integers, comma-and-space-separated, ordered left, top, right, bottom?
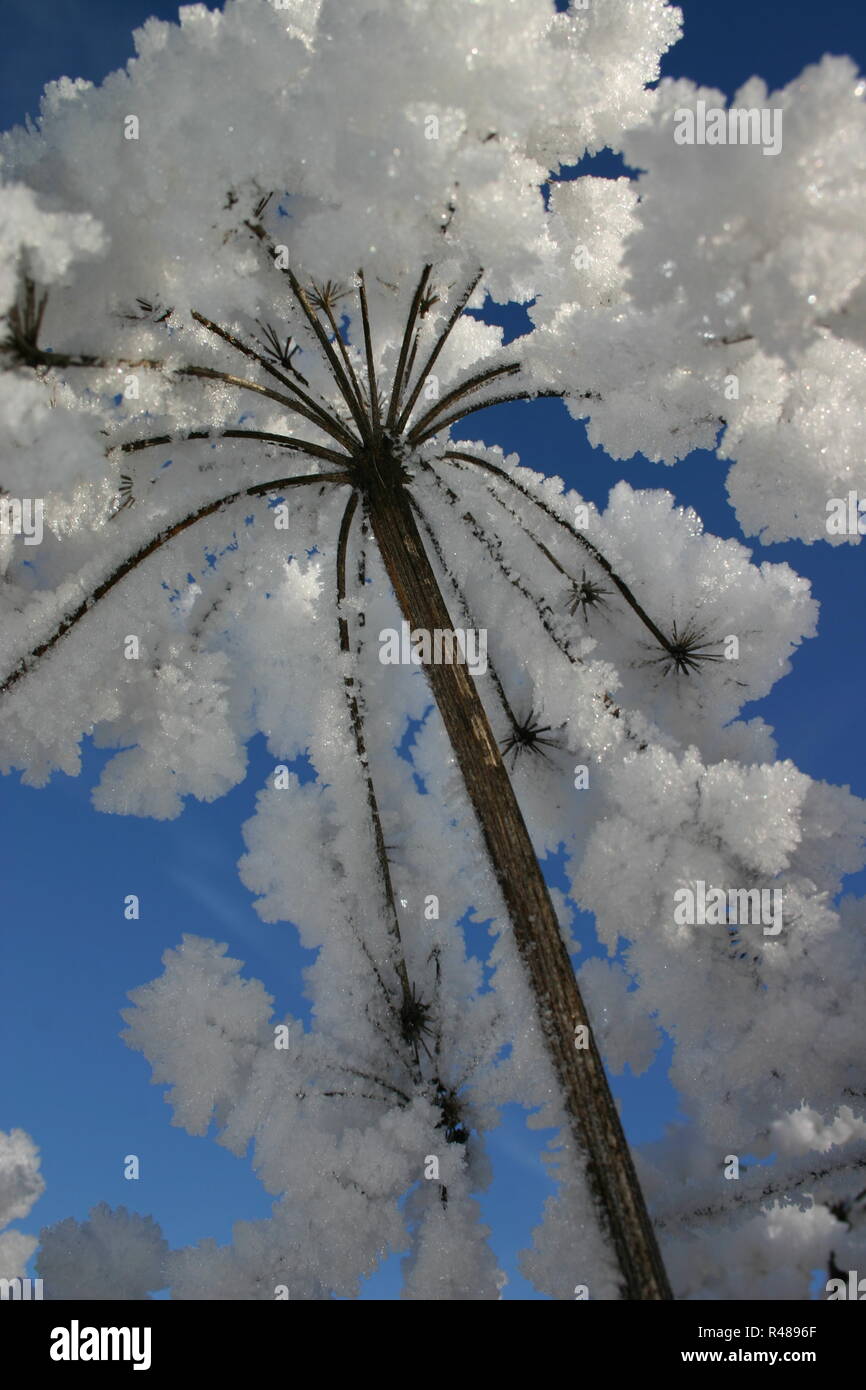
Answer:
0, 0, 866, 1298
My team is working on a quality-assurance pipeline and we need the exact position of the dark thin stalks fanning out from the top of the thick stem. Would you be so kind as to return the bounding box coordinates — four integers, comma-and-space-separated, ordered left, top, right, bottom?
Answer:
0, 193, 719, 711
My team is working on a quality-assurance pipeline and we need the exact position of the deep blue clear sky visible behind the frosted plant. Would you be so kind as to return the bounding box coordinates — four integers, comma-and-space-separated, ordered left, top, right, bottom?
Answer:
0, 0, 866, 1298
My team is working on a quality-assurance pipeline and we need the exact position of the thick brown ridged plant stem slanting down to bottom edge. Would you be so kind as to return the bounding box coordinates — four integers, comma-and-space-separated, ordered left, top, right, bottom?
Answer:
364, 457, 673, 1301
